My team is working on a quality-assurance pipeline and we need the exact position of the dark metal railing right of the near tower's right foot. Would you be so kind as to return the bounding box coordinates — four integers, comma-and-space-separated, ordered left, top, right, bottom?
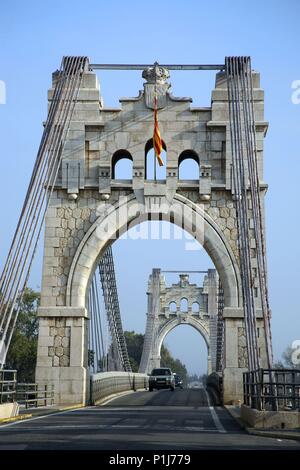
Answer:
243, 369, 300, 411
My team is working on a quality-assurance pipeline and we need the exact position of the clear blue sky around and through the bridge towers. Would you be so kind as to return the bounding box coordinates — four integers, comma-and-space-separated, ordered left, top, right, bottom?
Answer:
0, 0, 300, 373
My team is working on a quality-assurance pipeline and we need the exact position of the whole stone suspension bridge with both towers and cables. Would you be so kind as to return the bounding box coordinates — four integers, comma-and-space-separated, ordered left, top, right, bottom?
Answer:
0, 57, 298, 448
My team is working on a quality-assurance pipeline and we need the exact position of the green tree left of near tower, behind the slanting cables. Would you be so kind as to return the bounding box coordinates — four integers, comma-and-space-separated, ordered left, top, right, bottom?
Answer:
5, 288, 40, 382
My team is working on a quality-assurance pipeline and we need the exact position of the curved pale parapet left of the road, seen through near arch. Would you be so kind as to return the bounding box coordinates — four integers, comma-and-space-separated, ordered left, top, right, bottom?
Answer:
90, 372, 149, 405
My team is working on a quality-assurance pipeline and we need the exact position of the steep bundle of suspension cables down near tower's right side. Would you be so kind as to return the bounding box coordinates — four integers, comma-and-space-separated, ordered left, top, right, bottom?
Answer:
225, 57, 272, 370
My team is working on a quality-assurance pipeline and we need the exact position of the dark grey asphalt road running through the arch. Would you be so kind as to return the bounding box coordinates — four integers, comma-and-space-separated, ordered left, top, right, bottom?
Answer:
0, 389, 300, 451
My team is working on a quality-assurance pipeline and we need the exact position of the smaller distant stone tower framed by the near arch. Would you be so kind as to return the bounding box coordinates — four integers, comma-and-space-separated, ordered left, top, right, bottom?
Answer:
139, 269, 219, 374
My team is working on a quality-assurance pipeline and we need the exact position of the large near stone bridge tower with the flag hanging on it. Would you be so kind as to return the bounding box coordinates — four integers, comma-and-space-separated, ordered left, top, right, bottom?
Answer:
36, 58, 267, 404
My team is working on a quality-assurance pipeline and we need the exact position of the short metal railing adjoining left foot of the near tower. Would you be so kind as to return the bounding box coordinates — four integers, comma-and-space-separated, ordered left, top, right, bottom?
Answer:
16, 383, 54, 408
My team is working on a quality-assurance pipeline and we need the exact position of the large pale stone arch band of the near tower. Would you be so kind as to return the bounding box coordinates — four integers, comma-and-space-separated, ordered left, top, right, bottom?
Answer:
66, 194, 241, 308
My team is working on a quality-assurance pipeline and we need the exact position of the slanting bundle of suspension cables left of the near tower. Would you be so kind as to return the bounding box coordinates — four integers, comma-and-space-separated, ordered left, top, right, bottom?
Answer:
0, 57, 88, 365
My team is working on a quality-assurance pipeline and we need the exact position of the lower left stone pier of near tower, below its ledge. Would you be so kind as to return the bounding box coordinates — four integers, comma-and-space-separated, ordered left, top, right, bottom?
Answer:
36, 307, 89, 405
